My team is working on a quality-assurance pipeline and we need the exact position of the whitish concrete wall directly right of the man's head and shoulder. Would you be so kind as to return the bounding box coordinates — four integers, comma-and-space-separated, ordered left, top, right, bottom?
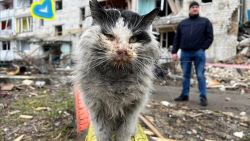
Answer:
198, 0, 240, 61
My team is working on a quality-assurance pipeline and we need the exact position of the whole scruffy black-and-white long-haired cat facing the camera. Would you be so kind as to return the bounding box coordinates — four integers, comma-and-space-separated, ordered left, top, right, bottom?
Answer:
74, 0, 158, 141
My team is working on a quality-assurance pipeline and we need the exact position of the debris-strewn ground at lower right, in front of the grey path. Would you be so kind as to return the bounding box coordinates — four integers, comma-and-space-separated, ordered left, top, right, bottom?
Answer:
145, 101, 250, 141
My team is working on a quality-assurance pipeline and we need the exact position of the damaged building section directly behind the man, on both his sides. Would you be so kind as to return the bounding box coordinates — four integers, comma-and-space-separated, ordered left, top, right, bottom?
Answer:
153, 0, 241, 61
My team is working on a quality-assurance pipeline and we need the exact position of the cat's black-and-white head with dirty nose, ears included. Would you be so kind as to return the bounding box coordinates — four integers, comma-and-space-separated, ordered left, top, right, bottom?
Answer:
90, 0, 158, 67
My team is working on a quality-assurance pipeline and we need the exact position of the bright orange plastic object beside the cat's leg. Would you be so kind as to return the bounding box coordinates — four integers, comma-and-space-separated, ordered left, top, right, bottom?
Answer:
74, 87, 90, 134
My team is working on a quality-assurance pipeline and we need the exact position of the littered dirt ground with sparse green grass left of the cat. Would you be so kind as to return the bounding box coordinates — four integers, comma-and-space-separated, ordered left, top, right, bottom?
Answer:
0, 81, 76, 141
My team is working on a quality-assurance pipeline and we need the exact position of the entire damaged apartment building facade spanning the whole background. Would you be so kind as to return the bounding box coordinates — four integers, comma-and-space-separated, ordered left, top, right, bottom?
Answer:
0, 0, 247, 62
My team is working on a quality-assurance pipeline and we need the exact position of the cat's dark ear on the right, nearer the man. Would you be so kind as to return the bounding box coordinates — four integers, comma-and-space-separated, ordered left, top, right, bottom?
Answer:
140, 8, 160, 30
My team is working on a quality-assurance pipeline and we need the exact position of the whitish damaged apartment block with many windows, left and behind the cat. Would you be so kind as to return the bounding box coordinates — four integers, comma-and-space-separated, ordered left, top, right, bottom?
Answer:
0, 0, 135, 66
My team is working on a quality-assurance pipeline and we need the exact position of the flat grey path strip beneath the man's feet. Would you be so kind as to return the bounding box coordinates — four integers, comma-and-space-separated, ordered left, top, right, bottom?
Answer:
152, 85, 250, 117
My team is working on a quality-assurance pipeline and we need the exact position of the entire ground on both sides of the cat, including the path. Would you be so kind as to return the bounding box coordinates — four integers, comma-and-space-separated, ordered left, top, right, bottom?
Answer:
0, 79, 250, 141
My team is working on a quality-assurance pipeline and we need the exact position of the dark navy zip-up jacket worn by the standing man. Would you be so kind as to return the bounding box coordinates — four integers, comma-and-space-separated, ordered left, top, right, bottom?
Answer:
172, 16, 214, 54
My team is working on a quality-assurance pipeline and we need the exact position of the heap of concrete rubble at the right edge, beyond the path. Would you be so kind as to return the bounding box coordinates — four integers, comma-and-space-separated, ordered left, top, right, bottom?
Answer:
206, 23, 250, 91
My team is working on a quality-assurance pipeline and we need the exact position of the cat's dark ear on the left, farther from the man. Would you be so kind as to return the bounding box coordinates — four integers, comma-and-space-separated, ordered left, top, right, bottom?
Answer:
89, 0, 106, 24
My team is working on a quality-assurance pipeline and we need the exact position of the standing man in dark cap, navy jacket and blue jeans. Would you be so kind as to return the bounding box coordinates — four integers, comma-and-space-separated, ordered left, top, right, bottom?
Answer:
172, 1, 213, 106
